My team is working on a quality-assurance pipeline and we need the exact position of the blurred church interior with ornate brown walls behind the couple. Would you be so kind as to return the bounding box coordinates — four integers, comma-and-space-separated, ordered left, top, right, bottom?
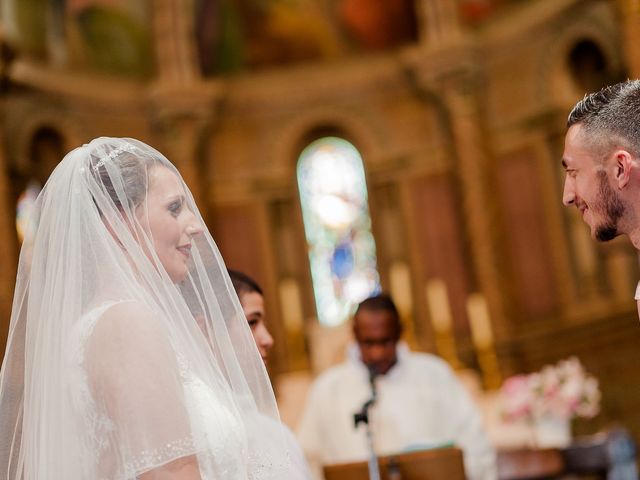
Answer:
0, 0, 640, 472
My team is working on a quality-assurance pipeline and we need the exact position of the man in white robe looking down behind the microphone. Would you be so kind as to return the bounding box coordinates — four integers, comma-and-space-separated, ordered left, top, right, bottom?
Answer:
298, 295, 496, 480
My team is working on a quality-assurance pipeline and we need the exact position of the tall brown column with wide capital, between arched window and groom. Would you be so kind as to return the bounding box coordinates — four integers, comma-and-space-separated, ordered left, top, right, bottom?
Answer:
403, 0, 509, 339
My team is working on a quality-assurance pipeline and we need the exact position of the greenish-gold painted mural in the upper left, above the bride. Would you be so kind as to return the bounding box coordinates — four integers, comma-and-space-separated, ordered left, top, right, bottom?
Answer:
2, 0, 154, 77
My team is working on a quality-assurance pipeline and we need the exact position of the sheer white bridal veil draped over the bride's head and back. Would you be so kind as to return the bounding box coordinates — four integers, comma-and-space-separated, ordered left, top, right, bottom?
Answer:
0, 138, 288, 480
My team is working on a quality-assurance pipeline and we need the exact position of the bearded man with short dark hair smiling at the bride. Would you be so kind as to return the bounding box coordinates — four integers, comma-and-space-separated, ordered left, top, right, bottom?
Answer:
562, 80, 640, 314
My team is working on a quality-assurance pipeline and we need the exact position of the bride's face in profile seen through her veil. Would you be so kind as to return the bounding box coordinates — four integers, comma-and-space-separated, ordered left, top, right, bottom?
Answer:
137, 166, 202, 283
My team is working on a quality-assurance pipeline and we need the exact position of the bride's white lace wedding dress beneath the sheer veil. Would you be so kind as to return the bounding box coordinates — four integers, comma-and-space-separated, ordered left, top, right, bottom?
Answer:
68, 302, 249, 480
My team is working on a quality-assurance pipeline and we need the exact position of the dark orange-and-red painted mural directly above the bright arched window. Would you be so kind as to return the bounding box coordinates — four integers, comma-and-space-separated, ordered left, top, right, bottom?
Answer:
195, 0, 417, 75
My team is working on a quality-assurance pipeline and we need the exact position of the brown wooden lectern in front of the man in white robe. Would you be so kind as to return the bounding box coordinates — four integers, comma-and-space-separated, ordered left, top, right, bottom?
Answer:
324, 448, 466, 480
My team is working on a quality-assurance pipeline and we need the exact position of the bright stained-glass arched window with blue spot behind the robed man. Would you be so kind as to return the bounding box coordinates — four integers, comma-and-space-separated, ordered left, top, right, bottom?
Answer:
298, 137, 380, 326
